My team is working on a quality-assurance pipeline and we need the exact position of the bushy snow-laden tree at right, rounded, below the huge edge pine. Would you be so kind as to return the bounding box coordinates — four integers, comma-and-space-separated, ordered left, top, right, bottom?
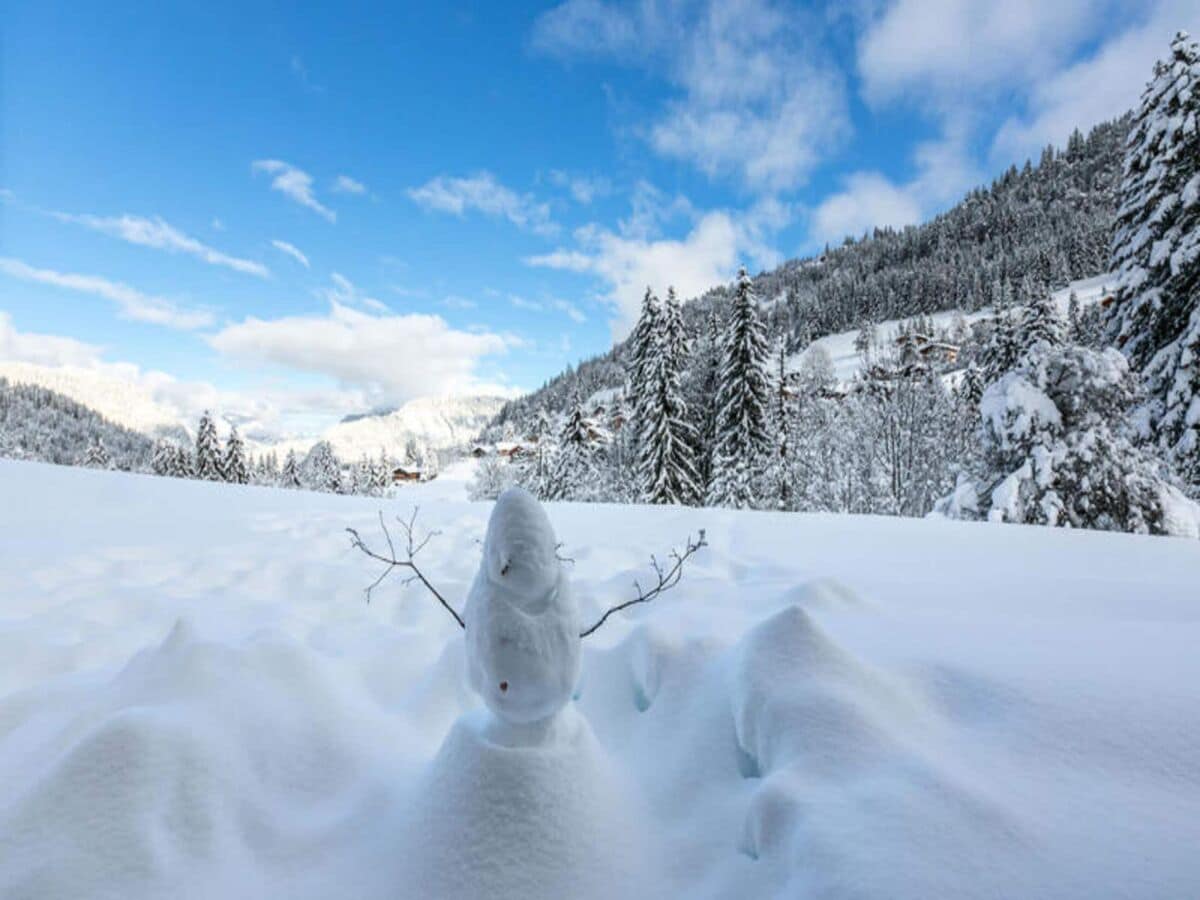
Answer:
937, 344, 1188, 534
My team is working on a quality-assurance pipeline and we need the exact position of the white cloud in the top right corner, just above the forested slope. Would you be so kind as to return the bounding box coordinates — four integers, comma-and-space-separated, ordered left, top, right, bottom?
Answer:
992, 0, 1200, 160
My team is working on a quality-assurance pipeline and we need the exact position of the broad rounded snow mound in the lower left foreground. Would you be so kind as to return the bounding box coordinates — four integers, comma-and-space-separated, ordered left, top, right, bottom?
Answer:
0, 622, 384, 898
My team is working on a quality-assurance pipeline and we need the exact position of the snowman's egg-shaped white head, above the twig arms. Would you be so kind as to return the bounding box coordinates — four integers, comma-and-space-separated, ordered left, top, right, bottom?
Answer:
484, 487, 559, 598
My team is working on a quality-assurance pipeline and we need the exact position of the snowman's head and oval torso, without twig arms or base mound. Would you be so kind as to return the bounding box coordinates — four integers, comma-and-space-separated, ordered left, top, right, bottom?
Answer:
463, 487, 580, 724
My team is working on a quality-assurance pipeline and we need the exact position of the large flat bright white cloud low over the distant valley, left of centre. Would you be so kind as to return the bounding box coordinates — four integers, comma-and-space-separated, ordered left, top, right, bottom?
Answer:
210, 302, 511, 403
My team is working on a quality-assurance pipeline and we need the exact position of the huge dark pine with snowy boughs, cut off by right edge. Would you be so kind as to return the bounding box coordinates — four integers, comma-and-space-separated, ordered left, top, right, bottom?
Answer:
1108, 31, 1200, 492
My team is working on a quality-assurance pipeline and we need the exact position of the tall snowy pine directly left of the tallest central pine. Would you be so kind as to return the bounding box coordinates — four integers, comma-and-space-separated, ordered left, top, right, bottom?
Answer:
637, 288, 700, 504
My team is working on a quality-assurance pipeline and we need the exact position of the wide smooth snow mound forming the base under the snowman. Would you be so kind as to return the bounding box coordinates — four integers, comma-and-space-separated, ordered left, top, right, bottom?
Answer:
402, 709, 658, 900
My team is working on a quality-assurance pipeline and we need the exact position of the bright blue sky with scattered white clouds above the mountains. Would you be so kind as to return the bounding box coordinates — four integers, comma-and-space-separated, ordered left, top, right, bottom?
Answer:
0, 0, 1200, 432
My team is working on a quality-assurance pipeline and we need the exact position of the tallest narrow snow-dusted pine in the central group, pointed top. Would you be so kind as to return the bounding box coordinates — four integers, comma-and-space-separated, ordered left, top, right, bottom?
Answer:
707, 268, 770, 509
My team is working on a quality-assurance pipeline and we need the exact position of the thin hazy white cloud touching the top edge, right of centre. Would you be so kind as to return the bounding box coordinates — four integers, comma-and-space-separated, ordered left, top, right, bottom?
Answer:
533, 0, 850, 191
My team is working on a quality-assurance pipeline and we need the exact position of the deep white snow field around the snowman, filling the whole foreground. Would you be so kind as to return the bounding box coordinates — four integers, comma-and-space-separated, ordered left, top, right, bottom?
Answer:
0, 461, 1200, 900
